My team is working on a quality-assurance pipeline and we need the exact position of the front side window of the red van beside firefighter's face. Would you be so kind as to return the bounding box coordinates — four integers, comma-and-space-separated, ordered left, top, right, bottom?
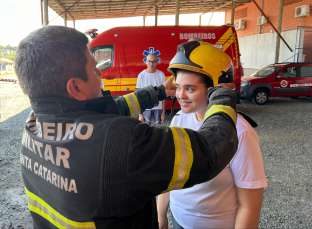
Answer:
91, 45, 114, 71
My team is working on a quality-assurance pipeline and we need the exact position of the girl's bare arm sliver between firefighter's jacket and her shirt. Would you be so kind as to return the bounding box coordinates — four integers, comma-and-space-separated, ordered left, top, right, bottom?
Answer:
157, 192, 170, 229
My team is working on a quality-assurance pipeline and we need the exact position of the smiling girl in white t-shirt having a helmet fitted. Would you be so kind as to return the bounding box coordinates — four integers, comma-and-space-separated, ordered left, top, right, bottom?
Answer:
157, 42, 267, 229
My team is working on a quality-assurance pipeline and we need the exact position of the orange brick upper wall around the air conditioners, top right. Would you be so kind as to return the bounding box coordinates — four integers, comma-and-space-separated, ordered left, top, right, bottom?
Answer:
225, 0, 312, 37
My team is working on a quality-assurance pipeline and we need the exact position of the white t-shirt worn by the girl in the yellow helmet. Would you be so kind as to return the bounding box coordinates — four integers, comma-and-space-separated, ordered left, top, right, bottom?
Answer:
170, 111, 268, 229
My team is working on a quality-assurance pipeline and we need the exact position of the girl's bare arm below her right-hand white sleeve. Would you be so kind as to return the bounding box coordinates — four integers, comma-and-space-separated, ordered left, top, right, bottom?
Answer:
235, 187, 264, 229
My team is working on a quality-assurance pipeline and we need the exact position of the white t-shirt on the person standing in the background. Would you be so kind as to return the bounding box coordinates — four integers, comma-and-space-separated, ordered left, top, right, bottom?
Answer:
136, 69, 166, 110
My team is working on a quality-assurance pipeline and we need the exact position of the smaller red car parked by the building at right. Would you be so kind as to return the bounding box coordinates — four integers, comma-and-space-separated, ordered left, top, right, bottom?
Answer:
241, 63, 312, 105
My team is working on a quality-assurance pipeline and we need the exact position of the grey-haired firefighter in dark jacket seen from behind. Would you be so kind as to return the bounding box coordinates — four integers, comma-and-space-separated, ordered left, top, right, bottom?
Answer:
15, 26, 238, 229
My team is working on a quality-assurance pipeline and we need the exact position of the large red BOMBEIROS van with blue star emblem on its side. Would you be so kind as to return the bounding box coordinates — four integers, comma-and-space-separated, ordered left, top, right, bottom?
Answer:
90, 25, 243, 109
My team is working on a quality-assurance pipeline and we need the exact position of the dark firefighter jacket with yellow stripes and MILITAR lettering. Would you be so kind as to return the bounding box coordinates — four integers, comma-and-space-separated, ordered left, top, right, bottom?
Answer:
21, 85, 238, 229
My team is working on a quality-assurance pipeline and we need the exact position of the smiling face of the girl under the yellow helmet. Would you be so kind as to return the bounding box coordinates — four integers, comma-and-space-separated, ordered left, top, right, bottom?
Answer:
175, 72, 208, 114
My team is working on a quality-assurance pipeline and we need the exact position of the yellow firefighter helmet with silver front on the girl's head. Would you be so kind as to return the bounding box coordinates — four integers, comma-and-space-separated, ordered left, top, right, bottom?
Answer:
168, 41, 233, 86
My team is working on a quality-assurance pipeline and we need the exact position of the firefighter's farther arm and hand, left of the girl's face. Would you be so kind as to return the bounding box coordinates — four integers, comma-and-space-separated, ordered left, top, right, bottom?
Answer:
115, 77, 175, 117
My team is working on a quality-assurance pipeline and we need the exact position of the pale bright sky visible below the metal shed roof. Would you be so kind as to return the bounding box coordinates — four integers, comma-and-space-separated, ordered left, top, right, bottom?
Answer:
0, 0, 225, 46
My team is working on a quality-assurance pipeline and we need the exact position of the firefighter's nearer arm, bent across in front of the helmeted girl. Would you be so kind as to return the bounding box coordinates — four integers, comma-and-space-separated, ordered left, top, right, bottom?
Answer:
127, 88, 238, 198
